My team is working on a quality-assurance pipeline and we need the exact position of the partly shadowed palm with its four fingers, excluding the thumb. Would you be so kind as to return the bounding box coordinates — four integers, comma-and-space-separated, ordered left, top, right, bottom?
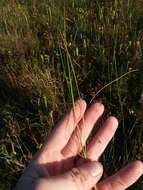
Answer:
15, 100, 143, 190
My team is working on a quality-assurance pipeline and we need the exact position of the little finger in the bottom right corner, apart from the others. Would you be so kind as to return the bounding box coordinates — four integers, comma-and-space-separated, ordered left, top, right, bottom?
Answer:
96, 160, 143, 190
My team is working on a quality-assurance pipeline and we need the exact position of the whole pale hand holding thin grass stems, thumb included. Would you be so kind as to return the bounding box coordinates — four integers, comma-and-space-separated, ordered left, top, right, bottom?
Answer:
16, 99, 143, 190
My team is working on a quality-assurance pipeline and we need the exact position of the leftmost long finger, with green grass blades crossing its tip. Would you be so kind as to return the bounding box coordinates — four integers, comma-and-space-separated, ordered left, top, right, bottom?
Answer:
36, 99, 86, 158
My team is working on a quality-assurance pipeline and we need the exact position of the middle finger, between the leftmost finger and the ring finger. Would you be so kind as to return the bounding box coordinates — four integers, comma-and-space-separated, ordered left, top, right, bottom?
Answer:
62, 103, 104, 157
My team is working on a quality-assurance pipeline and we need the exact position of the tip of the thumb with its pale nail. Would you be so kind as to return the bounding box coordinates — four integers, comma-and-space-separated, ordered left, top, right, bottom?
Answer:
87, 162, 103, 177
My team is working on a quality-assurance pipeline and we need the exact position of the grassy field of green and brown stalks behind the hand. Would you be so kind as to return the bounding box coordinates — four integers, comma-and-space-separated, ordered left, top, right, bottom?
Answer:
0, 0, 143, 190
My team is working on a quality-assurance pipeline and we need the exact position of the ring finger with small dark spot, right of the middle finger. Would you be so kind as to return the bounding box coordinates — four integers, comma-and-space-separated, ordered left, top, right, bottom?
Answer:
87, 117, 118, 161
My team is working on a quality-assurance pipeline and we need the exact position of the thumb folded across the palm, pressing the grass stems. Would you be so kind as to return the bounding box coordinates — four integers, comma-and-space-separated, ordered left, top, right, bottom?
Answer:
34, 162, 103, 190
